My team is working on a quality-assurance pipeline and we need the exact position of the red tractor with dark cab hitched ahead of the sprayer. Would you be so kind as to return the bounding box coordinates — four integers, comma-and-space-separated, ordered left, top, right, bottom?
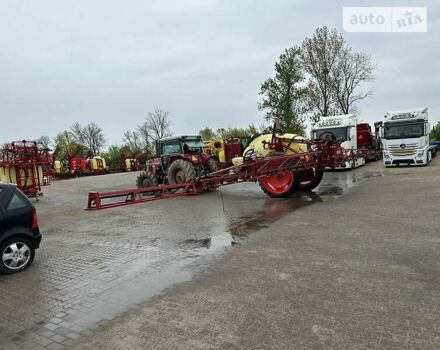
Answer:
136, 136, 218, 188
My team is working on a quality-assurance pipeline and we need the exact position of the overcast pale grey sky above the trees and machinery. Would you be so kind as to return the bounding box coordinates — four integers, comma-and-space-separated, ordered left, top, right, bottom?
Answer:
0, 0, 440, 144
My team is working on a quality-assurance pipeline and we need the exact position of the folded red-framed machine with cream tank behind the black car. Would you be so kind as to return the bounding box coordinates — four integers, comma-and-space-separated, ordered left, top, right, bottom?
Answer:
0, 140, 52, 197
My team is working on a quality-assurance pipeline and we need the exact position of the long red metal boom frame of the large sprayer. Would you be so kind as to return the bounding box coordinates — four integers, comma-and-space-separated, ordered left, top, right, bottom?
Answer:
85, 135, 369, 210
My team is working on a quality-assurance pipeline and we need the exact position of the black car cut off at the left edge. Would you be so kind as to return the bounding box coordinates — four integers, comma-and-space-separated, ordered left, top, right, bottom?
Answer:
0, 184, 41, 274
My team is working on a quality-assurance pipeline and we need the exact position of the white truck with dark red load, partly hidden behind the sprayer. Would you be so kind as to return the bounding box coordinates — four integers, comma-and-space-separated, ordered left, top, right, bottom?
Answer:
312, 114, 382, 169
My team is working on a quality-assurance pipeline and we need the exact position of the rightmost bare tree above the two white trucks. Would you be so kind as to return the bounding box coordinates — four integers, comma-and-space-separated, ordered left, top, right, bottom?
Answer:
331, 48, 375, 114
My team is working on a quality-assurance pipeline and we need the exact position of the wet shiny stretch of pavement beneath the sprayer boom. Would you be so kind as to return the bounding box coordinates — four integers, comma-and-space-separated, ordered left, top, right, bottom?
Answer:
0, 168, 381, 349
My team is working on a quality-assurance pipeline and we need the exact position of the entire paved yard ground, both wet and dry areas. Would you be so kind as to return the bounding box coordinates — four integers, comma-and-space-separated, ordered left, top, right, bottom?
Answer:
0, 162, 440, 349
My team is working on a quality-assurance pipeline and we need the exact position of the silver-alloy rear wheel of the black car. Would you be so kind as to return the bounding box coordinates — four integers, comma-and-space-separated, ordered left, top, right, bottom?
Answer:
0, 237, 35, 274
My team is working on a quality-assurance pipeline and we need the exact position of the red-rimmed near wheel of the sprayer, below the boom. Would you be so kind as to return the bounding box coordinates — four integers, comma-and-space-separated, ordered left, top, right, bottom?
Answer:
258, 171, 301, 198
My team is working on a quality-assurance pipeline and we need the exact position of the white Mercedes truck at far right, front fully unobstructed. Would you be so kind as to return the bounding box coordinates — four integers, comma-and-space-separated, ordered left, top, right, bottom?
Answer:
382, 108, 431, 167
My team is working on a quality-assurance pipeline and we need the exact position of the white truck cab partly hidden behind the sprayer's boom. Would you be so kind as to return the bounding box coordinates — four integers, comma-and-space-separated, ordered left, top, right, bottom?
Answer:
311, 114, 366, 169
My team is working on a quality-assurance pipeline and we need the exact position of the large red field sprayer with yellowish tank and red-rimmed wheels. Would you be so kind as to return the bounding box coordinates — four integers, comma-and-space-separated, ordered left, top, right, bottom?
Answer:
85, 123, 363, 210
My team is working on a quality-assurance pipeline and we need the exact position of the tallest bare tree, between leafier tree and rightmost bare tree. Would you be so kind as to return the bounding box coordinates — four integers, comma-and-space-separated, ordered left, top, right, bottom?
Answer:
301, 27, 346, 121
